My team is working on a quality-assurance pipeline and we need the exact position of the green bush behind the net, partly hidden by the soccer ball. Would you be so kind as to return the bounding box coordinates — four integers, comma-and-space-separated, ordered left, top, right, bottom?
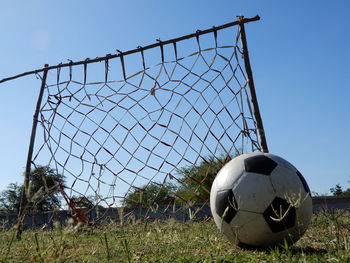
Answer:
177, 155, 232, 202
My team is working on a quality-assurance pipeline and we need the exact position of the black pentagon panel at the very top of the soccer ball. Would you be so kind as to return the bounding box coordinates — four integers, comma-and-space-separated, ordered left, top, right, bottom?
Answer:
244, 155, 277, 175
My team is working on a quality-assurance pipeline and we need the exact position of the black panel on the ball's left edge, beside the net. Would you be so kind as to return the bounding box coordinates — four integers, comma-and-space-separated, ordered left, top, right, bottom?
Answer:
215, 189, 237, 224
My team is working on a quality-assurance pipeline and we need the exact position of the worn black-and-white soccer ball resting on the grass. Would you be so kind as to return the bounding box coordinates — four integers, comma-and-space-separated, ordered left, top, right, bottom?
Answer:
210, 152, 312, 248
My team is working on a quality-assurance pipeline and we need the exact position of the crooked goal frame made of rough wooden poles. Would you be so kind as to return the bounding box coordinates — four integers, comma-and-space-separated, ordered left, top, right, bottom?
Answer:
0, 16, 268, 239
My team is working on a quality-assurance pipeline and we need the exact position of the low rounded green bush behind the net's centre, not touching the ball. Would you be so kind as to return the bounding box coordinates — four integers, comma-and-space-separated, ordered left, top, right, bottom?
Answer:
124, 183, 177, 207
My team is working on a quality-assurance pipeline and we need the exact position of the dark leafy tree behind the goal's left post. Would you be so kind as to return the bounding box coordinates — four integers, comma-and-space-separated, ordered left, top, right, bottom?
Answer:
0, 166, 65, 213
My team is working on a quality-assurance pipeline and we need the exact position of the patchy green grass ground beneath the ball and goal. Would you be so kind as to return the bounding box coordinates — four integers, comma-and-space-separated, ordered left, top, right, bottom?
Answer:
0, 211, 350, 263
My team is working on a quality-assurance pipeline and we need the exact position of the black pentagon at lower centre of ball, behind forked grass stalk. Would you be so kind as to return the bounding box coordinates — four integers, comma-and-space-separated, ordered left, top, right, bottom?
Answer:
263, 197, 296, 233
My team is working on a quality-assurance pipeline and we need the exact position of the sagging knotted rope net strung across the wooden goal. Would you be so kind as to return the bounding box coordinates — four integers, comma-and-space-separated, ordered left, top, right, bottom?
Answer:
28, 22, 260, 222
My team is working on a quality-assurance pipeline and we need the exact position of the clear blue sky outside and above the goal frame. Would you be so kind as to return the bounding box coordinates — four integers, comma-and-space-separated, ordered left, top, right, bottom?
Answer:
0, 0, 350, 193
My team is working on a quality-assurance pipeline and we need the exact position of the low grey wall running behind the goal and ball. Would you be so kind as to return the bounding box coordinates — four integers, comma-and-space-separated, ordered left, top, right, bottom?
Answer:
0, 196, 350, 229
